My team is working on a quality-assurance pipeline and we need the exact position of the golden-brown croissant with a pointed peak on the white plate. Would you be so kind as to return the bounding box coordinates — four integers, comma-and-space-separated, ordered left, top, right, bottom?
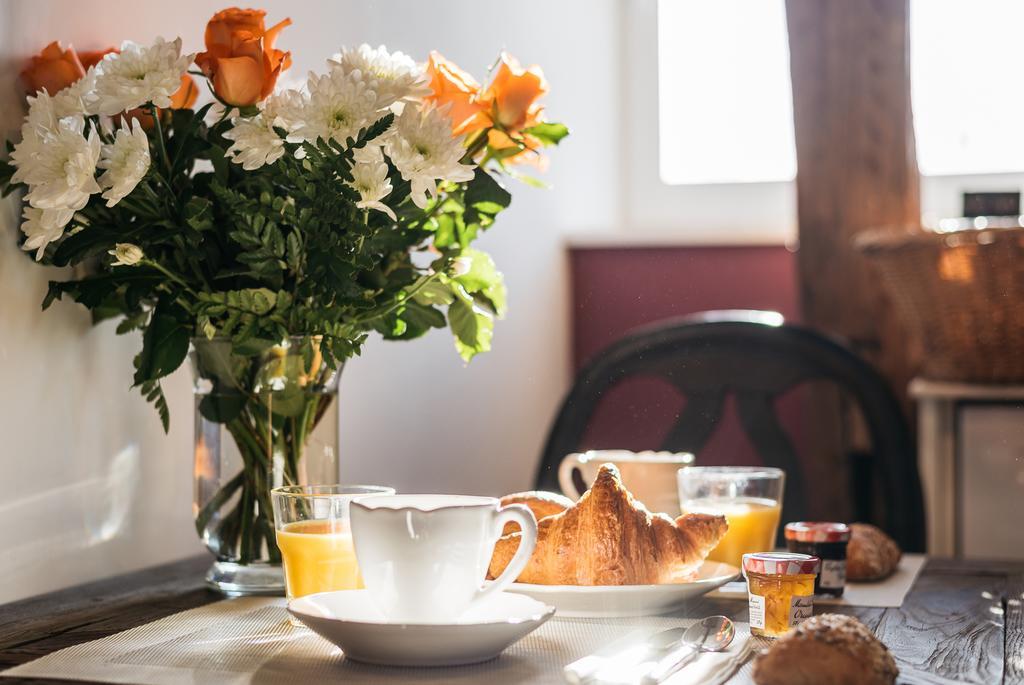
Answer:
489, 464, 729, 586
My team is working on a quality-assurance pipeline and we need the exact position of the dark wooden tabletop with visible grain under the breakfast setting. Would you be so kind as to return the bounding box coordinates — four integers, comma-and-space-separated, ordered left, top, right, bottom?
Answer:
0, 557, 1024, 685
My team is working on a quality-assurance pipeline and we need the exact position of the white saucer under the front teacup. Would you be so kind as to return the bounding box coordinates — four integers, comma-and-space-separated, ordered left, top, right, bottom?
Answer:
288, 590, 555, 666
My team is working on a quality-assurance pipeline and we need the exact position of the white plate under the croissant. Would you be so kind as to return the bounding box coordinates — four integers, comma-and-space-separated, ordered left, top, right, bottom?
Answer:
509, 561, 739, 618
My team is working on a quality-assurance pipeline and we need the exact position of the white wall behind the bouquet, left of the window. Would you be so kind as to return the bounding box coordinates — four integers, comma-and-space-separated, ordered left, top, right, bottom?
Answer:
0, 0, 623, 602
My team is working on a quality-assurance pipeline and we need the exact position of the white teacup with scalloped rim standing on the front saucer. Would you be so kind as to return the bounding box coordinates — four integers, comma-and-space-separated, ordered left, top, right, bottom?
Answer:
350, 495, 537, 623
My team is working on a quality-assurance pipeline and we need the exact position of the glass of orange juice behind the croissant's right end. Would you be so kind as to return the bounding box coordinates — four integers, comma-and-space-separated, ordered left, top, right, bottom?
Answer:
678, 466, 785, 568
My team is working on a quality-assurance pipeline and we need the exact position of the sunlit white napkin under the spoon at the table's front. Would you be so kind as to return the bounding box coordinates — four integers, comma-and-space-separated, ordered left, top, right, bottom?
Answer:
565, 624, 753, 685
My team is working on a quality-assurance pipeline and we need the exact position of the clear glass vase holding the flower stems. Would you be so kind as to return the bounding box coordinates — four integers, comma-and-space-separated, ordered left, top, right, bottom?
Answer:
189, 338, 340, 596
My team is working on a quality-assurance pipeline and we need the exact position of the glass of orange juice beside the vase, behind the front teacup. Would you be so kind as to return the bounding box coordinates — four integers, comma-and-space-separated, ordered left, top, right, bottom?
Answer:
270, 485, 394, 599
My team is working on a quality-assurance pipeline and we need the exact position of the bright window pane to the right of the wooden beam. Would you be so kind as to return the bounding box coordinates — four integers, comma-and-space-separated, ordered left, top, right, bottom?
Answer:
910, 0, 1024, 175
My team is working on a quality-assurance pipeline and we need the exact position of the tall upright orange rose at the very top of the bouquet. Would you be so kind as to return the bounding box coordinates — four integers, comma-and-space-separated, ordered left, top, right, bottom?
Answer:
196, 7, 292, 106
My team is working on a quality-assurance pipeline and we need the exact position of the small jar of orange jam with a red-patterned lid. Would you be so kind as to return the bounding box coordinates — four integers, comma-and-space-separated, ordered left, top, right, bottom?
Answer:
743, 552, 821, 638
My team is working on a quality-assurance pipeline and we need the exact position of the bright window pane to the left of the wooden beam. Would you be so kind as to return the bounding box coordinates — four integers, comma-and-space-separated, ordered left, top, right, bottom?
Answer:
657, 0, 797, 184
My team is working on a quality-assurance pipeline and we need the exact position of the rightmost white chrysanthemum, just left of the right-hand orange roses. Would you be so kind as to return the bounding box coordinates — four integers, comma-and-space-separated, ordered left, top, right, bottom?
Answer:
384, 103, 473, 208
